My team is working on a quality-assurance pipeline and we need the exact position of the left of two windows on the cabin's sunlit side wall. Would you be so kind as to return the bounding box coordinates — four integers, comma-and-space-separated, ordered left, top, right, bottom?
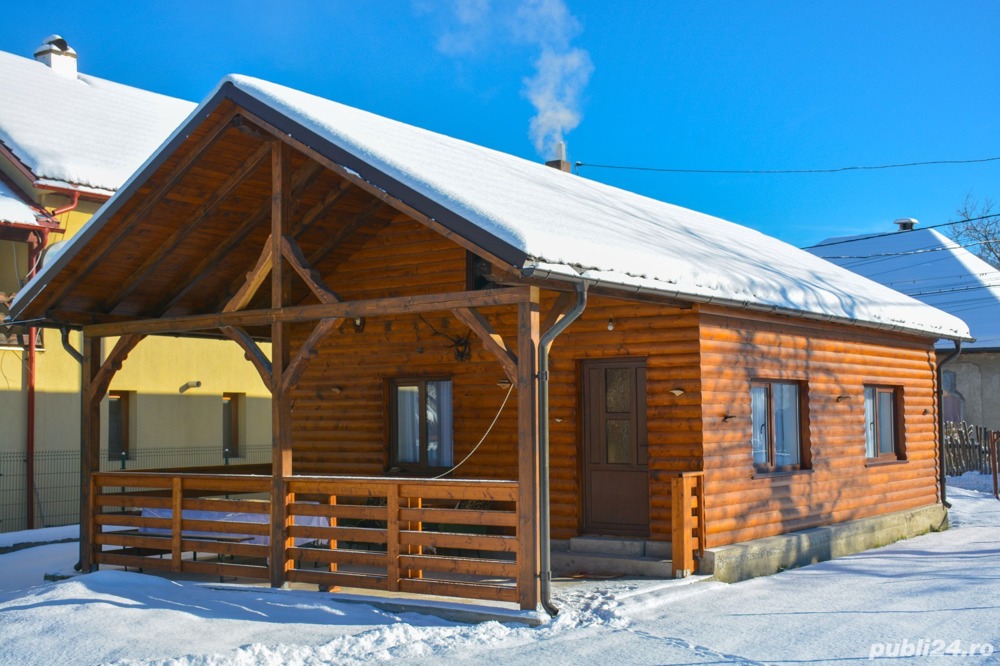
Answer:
750, 382, 808, 472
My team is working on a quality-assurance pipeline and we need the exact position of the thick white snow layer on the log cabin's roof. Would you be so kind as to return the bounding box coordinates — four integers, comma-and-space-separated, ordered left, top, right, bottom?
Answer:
220, 75, 968, 338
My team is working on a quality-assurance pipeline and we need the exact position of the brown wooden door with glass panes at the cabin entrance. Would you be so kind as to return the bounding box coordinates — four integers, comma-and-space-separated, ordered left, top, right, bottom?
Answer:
583, 358, 649, 536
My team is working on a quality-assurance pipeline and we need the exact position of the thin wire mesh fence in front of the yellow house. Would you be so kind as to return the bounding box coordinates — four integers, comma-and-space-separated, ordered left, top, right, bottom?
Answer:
0, 444, 271, 532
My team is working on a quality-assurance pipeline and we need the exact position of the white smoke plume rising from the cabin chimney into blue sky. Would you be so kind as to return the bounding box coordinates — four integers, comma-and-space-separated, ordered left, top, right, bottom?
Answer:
424, 0, 594, 159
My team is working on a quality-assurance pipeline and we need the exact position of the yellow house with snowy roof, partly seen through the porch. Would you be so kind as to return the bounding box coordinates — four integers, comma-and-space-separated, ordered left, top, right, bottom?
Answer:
0, 35, 270, 531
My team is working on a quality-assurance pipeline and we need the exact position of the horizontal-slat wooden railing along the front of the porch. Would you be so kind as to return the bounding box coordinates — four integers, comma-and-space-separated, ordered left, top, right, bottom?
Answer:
92, 472, 520, 602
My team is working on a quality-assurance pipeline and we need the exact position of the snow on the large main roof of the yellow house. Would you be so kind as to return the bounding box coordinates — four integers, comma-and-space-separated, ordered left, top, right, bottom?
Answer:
0, 46, 194, 195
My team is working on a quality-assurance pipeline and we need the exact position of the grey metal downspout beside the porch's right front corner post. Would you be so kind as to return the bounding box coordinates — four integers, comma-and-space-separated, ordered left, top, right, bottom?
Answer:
538, 281, 588, 617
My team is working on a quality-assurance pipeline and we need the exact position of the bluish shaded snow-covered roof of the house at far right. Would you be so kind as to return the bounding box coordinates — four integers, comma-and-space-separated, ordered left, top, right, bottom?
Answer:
809, 229, 1000, 349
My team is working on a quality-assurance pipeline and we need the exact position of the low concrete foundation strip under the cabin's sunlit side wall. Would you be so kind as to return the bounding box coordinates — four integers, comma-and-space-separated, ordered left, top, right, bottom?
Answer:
698, 504, 948, 583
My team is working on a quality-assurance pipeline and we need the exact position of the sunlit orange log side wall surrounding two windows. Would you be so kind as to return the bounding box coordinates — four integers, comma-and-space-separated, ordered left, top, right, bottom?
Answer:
701, 308, 937, 547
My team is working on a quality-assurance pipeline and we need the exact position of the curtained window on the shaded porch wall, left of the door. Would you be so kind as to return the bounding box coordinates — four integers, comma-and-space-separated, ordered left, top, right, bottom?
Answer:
389, 379, 453, 471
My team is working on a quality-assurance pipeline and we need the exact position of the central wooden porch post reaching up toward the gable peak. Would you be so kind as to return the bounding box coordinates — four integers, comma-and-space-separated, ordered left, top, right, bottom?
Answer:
269, 141, 292, 587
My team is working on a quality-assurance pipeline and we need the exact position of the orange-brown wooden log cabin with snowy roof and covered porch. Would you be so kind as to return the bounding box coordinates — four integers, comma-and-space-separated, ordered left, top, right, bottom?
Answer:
11, 76, 968, 609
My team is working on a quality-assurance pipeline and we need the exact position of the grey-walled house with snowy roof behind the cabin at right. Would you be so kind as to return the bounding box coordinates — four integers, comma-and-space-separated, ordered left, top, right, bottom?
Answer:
809, 219, 1000, 430
